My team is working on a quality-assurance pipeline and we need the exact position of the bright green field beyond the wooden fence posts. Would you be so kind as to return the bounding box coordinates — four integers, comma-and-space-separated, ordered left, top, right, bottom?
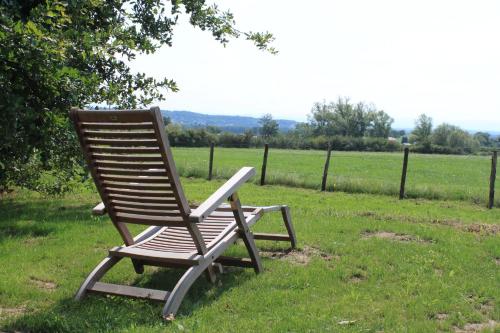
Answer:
174, 148, 500, 206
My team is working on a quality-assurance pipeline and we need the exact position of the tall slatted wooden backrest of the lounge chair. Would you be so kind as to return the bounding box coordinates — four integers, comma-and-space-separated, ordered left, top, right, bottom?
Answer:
70, 108, 190, 243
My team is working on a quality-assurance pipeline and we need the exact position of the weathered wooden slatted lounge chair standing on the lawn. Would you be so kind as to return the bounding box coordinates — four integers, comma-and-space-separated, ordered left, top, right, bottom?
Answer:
70, 108, 295, 319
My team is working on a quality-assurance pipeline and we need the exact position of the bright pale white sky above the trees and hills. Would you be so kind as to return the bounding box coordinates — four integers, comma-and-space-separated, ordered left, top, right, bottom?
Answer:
132, 0, 500, 131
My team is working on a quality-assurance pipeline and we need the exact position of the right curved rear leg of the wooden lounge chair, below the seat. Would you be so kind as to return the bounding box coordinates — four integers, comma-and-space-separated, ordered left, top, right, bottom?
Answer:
162, 262, 206, 320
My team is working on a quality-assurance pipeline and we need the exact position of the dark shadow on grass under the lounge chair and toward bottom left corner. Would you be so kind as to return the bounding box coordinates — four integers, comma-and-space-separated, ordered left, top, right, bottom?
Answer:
2, 263, 250, 332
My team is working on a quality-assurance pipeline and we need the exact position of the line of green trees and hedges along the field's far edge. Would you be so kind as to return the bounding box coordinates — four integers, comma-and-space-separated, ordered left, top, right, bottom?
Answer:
166, 98, 500, 154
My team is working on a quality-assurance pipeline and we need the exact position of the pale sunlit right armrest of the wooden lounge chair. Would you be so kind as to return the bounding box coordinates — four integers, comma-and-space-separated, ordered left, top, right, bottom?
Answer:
189, 167, 255, 223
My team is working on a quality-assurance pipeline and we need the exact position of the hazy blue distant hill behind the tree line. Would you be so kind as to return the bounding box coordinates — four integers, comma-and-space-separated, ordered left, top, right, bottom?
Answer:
161, 110, 297, 133
